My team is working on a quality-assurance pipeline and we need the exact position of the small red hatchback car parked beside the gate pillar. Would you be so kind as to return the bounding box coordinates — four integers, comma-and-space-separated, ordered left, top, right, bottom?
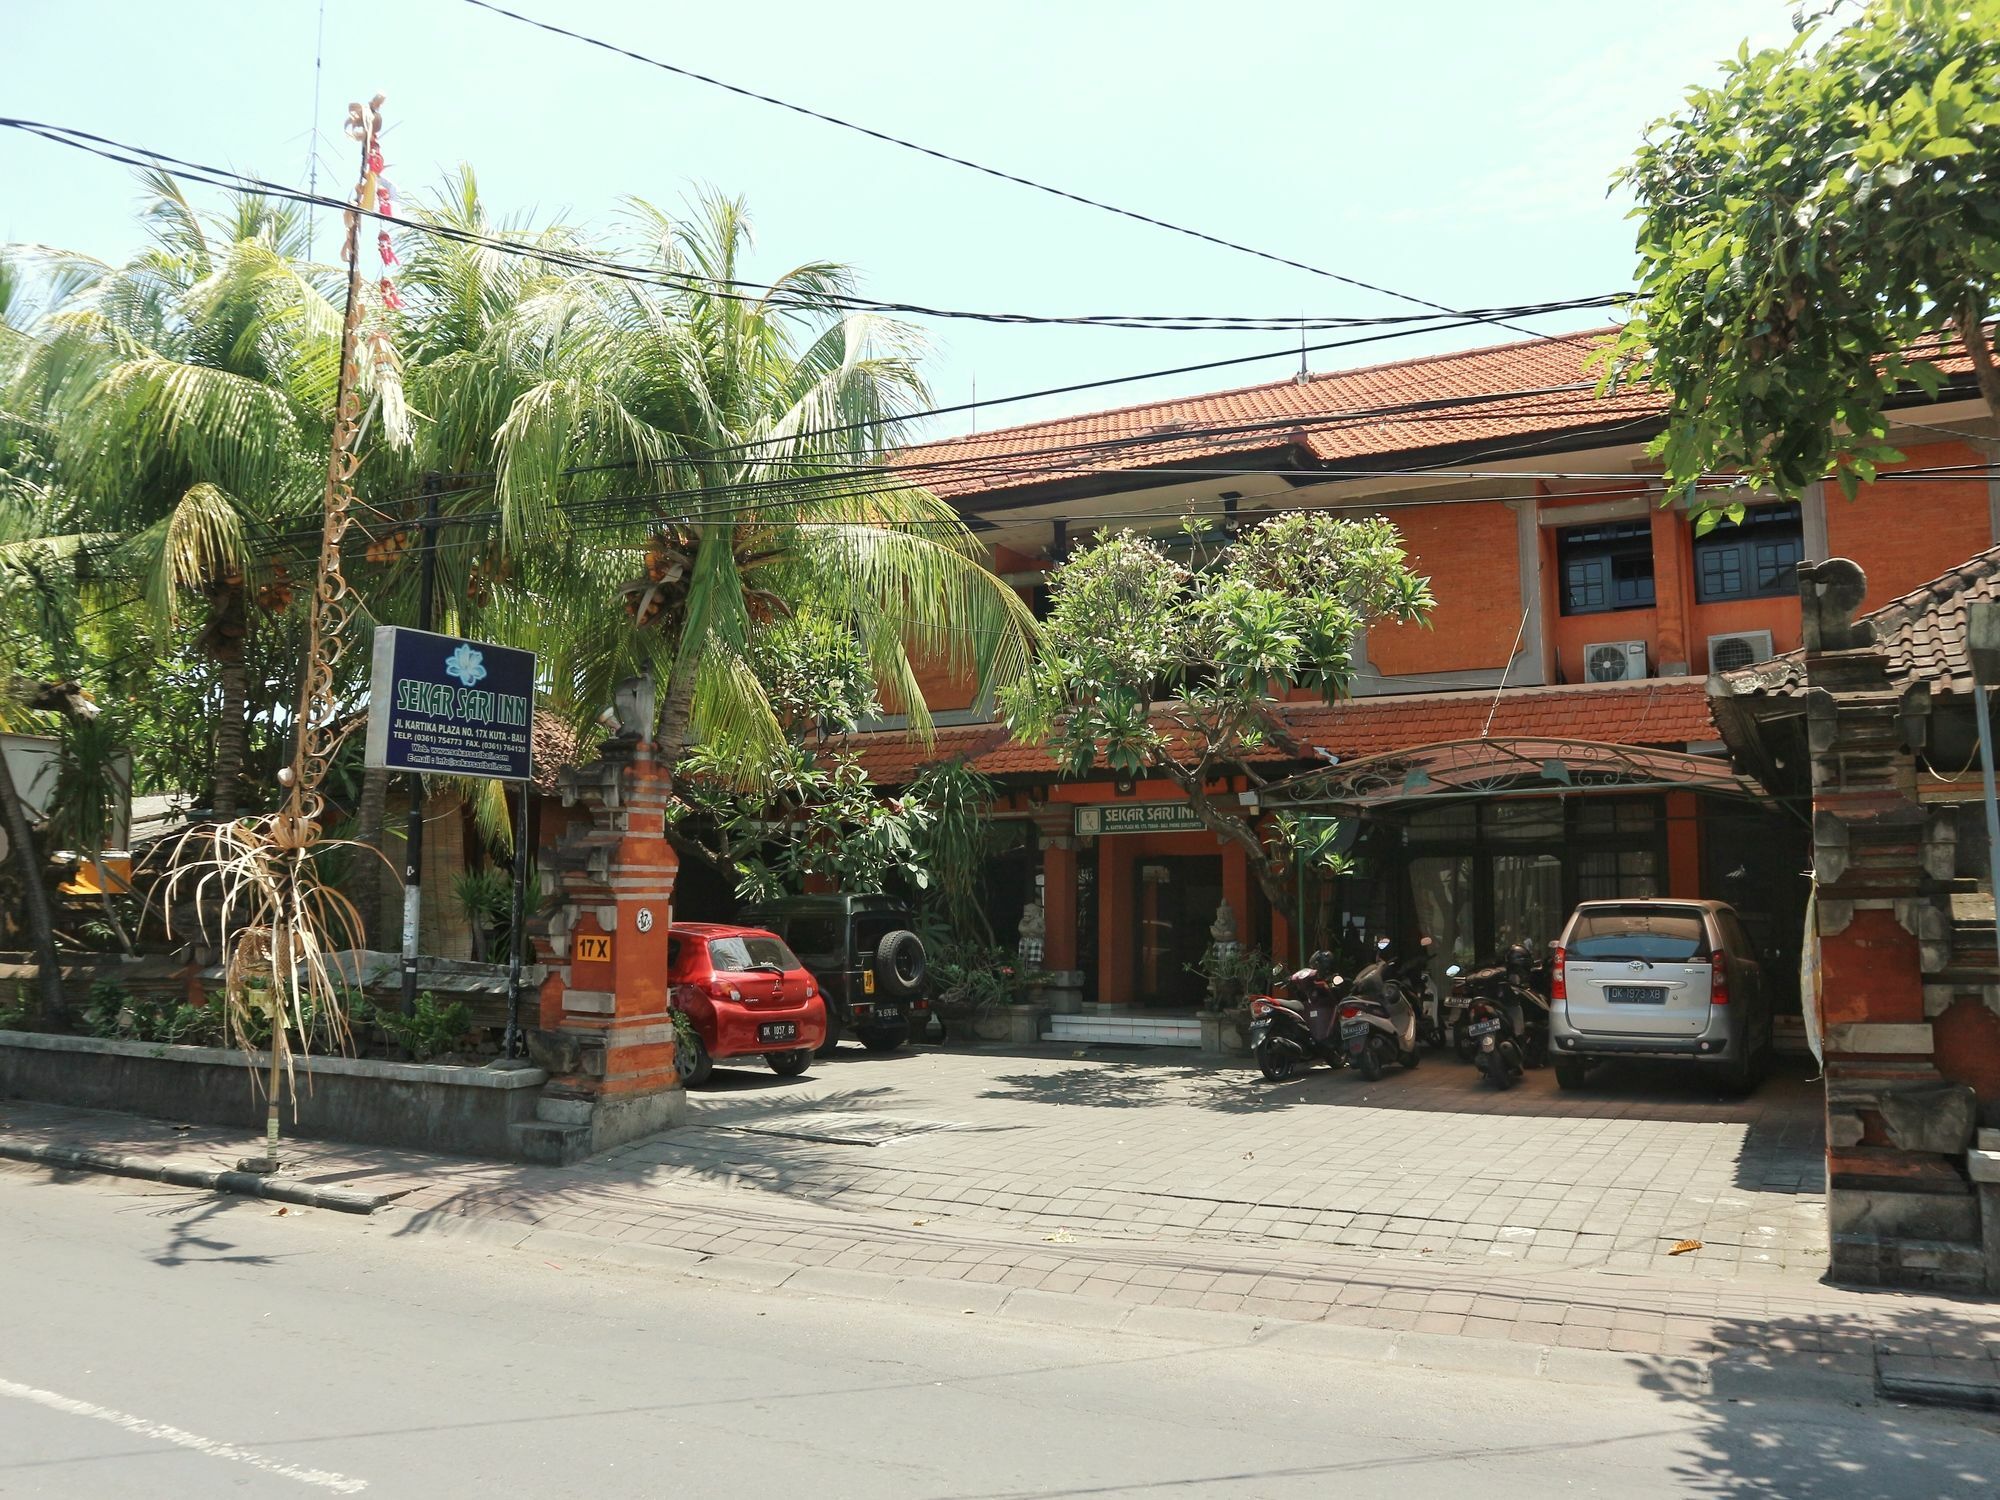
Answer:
666, 922, 826, 1084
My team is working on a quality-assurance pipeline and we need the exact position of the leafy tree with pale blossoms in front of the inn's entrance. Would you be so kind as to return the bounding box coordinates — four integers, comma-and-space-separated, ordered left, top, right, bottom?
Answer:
1002, 512, 1430, 906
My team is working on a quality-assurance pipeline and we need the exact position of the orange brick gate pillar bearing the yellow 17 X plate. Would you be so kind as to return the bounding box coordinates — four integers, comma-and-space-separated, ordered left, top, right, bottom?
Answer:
518, 682, 686, 1162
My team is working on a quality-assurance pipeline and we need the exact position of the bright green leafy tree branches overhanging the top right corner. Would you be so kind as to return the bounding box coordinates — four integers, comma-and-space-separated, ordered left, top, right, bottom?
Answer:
1604, 0, 2000, 524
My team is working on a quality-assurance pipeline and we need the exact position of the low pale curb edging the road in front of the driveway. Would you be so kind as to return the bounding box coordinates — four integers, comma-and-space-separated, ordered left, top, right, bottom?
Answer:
386, 1214, 1910, 1402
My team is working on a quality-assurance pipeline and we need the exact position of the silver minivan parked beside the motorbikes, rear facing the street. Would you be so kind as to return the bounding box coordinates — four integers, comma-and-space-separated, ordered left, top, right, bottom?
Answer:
1550, 900, 1770, 1092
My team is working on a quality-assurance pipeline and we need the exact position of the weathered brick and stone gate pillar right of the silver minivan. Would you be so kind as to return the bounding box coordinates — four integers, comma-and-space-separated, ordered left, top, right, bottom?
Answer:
1800, 558, 1984, 1290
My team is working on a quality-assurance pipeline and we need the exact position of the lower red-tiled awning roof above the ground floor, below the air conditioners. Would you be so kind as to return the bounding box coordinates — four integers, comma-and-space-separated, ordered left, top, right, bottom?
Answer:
842, 678, 1718, 786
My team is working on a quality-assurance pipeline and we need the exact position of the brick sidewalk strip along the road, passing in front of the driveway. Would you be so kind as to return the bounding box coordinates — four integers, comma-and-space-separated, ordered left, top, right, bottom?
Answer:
0, 1102, 2000, 1404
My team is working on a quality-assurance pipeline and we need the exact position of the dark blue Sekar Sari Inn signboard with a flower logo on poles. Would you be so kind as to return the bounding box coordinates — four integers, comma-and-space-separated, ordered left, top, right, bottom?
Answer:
368, 626, 534, 782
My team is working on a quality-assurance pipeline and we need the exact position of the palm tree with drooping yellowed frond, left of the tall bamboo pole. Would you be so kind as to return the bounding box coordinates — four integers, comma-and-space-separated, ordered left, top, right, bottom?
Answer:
16, 185, 340, 836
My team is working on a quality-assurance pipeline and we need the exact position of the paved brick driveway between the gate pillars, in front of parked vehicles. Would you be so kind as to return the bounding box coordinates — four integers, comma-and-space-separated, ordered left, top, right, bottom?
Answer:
600, 1048, 1826, 1280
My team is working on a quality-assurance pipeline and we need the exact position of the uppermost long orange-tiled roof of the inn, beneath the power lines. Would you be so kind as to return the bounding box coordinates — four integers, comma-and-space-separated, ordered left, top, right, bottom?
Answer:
896, 328, 1662, 498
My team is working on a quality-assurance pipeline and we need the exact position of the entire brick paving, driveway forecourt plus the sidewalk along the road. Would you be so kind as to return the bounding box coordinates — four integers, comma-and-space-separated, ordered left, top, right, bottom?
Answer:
0, 1052, 2000, 1386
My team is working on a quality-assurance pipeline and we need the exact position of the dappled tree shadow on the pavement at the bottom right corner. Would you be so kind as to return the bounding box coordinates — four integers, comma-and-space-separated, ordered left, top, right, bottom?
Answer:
1634, 1300, 2000, 1500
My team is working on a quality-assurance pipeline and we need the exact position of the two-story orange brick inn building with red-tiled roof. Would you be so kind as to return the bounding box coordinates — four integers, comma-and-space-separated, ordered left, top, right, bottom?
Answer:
844, 334, 2000, 1032
